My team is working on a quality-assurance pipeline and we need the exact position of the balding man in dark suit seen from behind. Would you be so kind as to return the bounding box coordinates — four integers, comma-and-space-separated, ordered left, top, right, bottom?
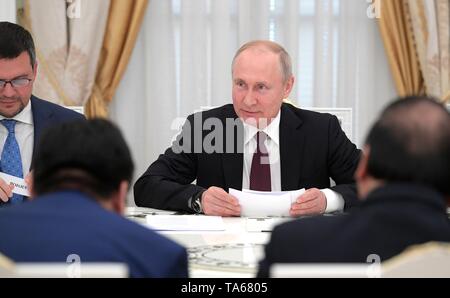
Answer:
259, 97, 450, 277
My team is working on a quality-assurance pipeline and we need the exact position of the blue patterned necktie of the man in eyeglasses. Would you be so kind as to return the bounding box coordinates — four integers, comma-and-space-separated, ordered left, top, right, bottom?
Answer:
0, 119, 23, 204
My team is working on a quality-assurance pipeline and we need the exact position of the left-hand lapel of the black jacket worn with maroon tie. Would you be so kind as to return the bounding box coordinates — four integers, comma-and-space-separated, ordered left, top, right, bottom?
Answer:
220, 105, 244, 191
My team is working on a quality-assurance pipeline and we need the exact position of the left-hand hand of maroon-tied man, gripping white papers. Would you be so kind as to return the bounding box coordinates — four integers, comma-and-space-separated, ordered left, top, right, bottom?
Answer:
202, 186, 241, 216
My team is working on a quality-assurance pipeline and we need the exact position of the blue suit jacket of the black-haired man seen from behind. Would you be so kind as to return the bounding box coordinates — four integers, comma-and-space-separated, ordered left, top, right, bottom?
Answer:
0, 191, 188, 277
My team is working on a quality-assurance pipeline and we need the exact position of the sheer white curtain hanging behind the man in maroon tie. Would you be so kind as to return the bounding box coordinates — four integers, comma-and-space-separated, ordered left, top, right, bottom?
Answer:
110, 0, 395, 203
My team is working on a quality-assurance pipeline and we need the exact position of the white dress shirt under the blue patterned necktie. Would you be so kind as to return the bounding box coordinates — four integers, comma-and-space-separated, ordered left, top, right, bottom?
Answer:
0, 102, 34, 178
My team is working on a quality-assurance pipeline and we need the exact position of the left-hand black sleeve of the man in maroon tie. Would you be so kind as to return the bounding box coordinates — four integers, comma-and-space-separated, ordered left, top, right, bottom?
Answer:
134, 115, 204, 212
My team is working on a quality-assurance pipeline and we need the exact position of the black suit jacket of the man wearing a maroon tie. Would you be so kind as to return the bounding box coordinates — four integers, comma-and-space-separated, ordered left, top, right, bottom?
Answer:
134, 104, 360, 212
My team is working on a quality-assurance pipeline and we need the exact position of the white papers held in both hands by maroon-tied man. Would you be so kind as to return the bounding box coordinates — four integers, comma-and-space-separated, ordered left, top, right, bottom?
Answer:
229, 188, 305, 217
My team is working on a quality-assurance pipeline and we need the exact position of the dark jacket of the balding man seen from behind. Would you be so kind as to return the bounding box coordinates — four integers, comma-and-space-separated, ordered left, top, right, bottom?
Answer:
258, 184, 450, 277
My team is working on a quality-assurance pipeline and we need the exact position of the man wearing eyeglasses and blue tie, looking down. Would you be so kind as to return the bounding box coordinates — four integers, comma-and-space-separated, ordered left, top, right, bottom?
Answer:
0, 22, 83, 207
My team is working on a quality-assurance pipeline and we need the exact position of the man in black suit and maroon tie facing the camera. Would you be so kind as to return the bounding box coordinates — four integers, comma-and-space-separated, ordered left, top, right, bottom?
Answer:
134, 41, 360, 216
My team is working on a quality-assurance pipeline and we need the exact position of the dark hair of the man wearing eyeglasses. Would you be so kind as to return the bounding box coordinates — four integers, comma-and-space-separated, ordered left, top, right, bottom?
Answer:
0, 22, 36, 69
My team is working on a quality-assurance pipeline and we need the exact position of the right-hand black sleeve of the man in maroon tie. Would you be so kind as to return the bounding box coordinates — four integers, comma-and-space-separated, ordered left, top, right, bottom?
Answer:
328, 116, 361, 211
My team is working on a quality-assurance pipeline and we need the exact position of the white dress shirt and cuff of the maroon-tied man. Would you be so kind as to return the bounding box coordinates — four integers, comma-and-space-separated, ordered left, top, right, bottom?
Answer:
242, 112, 344, 213
